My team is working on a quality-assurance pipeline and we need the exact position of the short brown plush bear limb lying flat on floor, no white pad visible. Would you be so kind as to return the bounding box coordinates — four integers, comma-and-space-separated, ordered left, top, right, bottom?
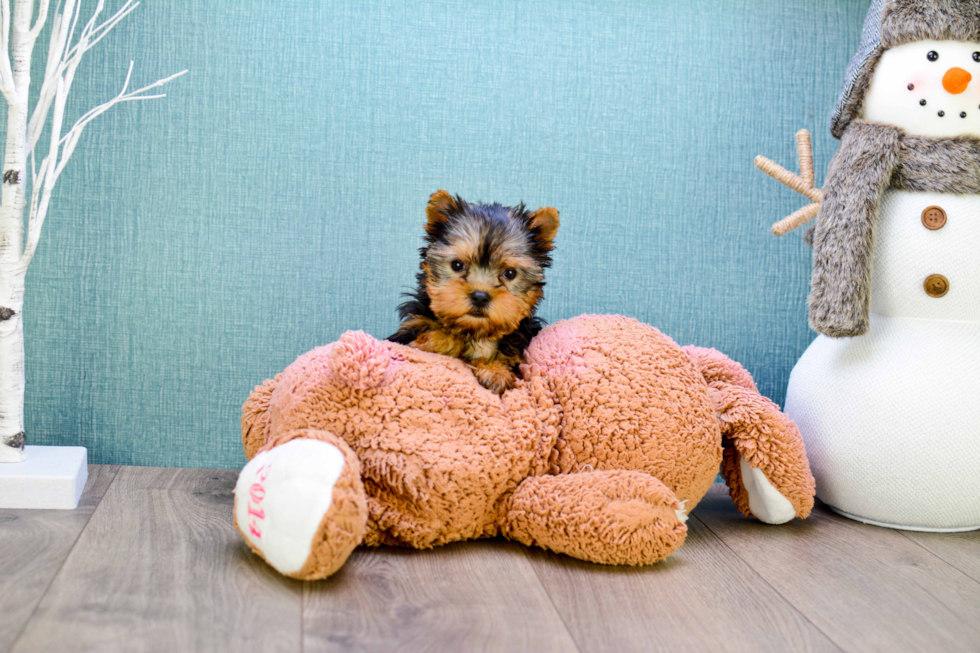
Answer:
502, 470, 687, 565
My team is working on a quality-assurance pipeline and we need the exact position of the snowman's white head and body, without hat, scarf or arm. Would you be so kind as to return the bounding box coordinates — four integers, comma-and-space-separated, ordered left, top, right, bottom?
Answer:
786, 40, 980, 531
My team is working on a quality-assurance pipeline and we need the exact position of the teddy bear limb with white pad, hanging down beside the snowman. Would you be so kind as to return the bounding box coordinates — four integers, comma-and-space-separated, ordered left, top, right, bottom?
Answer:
684, 347, 814, 524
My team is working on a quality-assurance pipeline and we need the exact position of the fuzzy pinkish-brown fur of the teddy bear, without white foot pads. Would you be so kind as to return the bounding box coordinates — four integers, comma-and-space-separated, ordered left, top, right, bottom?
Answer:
235, 316, 813, 579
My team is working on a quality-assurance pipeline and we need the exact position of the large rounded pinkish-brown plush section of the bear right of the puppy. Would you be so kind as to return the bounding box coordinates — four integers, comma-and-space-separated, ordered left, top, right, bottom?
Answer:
525, 316, 720, 506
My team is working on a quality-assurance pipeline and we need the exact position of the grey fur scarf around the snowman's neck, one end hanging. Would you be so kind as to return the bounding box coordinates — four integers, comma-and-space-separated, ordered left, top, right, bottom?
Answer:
808, 120, 980, 338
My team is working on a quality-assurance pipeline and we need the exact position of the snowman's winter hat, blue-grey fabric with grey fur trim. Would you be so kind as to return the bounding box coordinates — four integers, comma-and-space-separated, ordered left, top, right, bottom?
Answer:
830, 0, 980, 138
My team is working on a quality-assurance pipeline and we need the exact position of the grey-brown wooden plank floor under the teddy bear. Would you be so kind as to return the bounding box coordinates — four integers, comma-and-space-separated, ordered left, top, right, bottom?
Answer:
0, 465, 980, 653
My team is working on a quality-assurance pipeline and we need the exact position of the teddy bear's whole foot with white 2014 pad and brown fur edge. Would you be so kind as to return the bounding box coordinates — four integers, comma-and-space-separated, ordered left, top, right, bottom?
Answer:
234, 429, 368, 580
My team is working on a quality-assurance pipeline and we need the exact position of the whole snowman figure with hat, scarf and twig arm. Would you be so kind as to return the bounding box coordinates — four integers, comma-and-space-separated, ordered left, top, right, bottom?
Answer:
757, 0, 980, 531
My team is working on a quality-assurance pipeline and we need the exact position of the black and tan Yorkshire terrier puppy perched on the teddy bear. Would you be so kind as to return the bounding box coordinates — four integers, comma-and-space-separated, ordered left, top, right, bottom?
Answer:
388, 190, 558, 394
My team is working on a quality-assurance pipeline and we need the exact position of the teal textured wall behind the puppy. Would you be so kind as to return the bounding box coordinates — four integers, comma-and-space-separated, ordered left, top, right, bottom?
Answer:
7, 0, 868, 467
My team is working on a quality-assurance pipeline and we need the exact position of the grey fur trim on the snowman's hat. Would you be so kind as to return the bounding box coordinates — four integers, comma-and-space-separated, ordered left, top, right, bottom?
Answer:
831, 0, 980, 138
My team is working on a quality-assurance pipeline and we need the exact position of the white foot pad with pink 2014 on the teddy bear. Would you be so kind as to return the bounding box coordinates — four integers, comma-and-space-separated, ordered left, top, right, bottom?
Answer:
235, 439, 344, 574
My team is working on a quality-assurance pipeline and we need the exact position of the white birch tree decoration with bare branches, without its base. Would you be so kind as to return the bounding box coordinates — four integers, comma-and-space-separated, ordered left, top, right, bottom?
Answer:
0, 0, 187, 463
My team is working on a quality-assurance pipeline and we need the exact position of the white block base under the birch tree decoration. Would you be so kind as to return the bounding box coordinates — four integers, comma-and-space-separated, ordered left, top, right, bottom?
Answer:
0, 445, 88, 510
